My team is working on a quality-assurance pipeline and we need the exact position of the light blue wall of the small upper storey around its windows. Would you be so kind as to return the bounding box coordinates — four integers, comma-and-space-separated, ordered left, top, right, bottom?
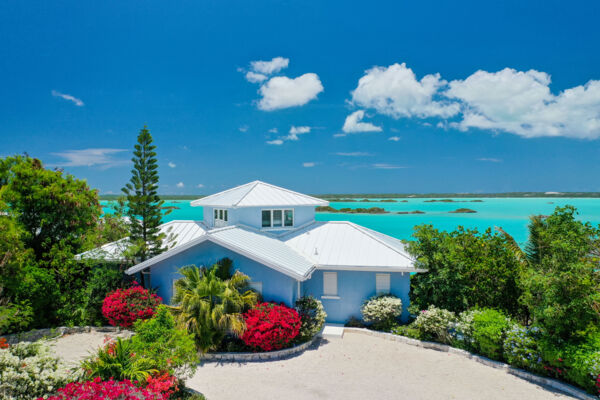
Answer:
203, 206, 315, 229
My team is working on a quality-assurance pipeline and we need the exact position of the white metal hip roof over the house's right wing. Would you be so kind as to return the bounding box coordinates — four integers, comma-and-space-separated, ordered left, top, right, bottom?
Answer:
281, 221, 417, 272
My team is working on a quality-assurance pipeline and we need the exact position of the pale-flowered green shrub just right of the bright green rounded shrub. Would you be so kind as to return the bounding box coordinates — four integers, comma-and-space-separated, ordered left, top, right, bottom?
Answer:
503, 324, 544, 373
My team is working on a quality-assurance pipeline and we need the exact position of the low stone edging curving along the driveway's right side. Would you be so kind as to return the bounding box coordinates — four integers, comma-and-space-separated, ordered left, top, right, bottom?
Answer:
344, 328, 598, 400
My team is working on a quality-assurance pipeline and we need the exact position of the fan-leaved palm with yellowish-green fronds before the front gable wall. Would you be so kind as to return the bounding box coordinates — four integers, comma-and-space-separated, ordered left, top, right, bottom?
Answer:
172, 264, 257, 352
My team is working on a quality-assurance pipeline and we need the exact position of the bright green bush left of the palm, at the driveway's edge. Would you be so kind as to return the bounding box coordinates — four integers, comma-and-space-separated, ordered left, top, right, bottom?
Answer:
131, 305, 200, 380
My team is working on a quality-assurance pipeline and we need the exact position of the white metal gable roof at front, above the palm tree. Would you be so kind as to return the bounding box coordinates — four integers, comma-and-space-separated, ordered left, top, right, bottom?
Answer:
126, 225, 315, 280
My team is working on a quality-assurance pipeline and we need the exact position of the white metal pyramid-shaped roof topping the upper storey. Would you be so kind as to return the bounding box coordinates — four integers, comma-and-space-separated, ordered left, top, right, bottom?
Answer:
191, 181, 329, 207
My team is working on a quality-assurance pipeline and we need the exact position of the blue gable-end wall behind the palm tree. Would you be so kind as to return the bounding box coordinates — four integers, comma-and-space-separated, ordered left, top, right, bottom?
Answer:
150, 241, 297, 306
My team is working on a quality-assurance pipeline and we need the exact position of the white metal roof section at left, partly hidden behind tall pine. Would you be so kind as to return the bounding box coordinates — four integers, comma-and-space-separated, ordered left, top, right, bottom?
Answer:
76, 220, 207, 261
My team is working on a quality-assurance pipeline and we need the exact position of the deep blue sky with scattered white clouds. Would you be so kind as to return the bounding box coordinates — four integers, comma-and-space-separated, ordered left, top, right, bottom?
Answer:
0, 0, 600, 194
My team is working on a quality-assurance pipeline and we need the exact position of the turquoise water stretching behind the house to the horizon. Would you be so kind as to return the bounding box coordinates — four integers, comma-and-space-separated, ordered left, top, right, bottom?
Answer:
101, 198, 600, 243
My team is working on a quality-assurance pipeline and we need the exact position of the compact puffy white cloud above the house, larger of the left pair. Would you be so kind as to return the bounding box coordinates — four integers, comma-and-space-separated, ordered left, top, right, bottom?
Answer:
258, 73, 323, 111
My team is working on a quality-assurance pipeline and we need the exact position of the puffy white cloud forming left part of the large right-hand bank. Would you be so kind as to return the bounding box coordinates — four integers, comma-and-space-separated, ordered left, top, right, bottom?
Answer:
352, 63, 459, 119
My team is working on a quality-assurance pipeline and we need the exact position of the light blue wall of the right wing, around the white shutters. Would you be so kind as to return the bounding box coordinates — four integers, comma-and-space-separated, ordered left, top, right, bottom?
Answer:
301, 270, 410, 324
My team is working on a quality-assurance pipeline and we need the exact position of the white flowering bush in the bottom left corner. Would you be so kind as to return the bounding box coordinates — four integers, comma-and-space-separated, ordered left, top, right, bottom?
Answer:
0, 342, 69, 400
